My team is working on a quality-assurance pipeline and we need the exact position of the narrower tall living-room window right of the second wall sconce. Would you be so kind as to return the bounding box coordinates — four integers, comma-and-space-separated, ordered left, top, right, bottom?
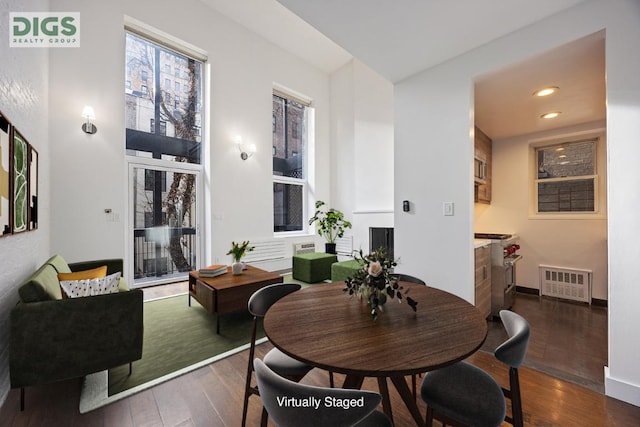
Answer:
272, 92, 312, 232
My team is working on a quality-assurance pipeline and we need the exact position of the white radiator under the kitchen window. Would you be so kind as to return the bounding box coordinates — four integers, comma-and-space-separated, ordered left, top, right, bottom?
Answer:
540, 265, 593, 304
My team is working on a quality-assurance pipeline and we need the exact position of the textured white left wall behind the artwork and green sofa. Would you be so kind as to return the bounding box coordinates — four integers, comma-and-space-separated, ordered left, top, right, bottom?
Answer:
0, 0, 50, 405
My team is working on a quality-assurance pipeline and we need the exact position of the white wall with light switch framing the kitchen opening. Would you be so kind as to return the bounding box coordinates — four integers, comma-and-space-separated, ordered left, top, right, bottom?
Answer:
394, 0, 640, 405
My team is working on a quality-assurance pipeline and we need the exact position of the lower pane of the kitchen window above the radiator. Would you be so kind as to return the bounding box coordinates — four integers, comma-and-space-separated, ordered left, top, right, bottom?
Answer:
538, 178, 595, 212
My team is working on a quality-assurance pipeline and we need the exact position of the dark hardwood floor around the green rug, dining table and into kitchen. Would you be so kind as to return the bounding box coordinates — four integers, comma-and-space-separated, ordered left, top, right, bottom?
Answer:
0, 285, 640, 427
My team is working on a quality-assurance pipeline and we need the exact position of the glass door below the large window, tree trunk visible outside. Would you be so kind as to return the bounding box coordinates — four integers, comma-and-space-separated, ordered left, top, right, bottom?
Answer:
129, 163, 200, 287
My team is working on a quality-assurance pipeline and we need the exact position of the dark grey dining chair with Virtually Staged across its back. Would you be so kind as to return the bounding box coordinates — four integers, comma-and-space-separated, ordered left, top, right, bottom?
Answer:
253, 358, 392, 427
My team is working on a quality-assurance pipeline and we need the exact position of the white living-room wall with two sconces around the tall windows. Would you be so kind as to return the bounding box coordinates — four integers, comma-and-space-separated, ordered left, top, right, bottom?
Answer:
51, 0, 330, 270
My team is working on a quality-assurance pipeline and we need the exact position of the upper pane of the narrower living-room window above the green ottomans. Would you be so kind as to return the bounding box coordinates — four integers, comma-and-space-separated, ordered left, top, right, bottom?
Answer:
273, 95, 307, 179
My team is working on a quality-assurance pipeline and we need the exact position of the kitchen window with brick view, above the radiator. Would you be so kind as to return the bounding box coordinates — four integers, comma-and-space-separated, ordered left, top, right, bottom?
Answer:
535, 139, 598, 213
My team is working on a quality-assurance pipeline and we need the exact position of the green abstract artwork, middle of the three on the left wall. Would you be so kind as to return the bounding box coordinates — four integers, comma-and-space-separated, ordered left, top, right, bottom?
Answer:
12, 128, 29, 233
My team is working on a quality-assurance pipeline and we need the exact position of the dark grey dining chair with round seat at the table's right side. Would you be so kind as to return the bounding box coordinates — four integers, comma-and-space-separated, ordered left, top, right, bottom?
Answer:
420, 310, 531, 427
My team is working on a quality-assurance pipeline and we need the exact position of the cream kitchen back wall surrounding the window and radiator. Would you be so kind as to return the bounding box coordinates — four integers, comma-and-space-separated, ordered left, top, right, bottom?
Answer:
475, 122, 608, 300
